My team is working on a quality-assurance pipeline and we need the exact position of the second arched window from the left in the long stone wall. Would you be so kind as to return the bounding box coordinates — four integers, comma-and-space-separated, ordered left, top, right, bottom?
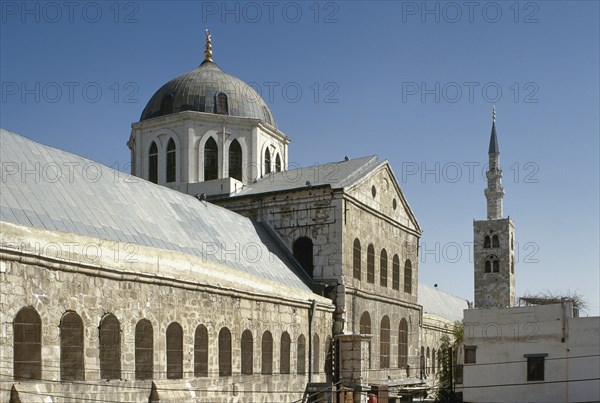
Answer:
60, 312, 85, 381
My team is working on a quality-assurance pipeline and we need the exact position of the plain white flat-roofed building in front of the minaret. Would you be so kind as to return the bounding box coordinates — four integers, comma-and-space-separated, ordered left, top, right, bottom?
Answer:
457, 302, 600, 403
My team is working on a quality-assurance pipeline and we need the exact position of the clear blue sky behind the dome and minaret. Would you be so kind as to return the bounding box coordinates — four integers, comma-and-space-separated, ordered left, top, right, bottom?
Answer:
0, 1, 600, 315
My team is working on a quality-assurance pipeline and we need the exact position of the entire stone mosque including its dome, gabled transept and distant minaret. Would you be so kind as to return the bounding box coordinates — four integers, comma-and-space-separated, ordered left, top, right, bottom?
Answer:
0, 32, 488, 403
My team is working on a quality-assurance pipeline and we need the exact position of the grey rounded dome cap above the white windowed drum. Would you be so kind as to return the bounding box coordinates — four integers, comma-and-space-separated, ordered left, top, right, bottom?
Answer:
140, 60, 275, 126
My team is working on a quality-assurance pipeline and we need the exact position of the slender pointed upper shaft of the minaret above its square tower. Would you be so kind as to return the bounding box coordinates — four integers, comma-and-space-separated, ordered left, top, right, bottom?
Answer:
484, 106, 504, 220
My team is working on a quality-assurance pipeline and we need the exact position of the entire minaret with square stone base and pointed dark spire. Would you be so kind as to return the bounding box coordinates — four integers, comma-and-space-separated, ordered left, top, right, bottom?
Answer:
473, 108, 515, 308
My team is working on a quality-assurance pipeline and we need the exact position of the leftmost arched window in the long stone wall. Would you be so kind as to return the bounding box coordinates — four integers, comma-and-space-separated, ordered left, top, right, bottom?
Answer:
13, 307, 42, 380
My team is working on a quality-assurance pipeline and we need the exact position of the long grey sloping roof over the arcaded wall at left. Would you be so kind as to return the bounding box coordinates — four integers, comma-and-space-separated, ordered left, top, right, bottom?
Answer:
0, 129, 310, 292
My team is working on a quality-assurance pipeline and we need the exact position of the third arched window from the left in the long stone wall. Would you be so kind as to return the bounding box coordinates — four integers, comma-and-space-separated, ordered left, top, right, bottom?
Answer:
99, 314, 121, 379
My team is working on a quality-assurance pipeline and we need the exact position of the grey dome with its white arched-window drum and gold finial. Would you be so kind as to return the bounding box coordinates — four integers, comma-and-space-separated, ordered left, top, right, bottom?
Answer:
127, 30, 290, 196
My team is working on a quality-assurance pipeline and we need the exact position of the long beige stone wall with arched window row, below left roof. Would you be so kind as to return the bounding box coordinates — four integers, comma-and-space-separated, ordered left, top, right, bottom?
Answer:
0, 226, 333, 402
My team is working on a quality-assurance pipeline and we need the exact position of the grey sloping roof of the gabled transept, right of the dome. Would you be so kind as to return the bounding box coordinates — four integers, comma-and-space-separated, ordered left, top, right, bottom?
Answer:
232, 156, 383, 197
